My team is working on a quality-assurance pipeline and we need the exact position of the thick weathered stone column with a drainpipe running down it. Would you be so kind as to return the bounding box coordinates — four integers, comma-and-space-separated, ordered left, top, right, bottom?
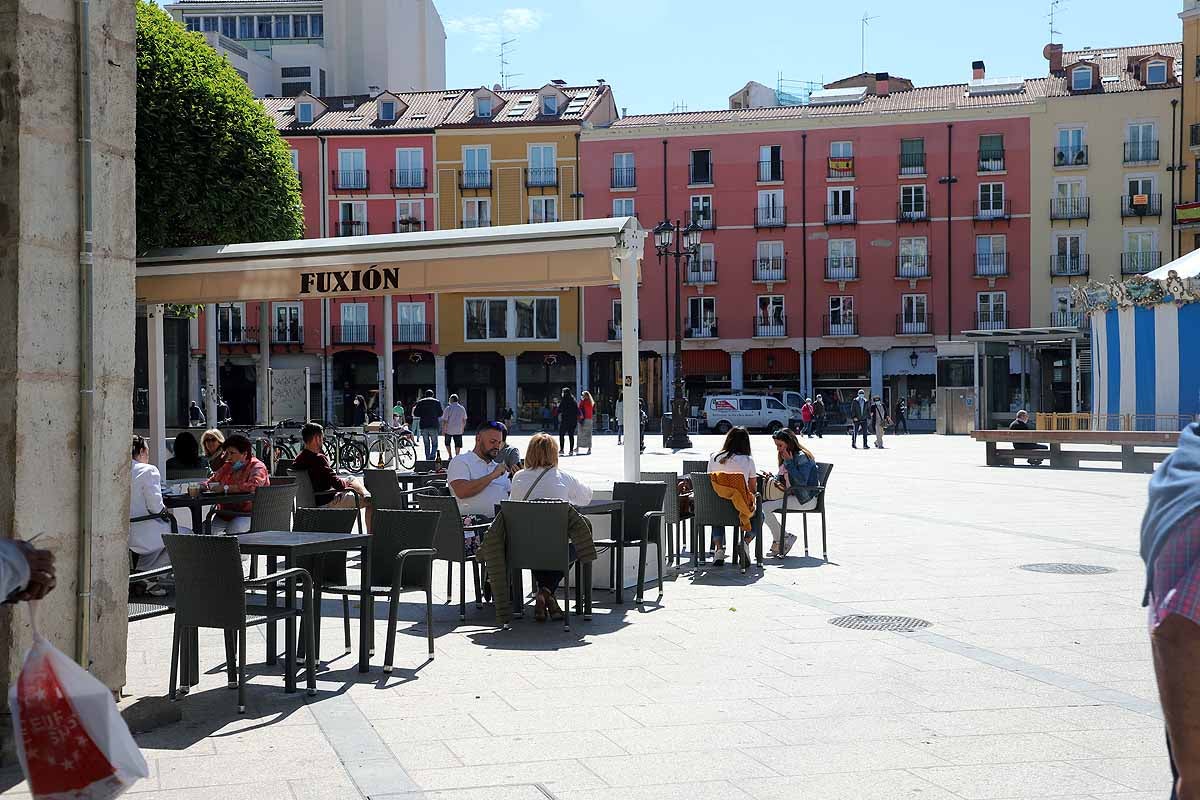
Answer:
0, 0, 136, 705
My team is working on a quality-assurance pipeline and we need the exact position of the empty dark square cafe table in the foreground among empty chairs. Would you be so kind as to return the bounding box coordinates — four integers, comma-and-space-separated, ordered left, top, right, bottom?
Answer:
238, 530, 374, 685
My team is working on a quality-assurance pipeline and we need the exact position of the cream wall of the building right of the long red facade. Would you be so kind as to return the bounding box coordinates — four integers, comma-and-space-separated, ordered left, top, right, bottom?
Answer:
1030, 89, 1180, 325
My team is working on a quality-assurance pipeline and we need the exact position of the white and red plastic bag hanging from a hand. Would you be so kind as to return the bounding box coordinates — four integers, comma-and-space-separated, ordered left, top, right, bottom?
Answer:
8, 603, 150, 800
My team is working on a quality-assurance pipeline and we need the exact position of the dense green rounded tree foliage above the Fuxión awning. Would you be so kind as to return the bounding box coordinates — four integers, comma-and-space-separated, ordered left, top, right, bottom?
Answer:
137, 0, 304, 252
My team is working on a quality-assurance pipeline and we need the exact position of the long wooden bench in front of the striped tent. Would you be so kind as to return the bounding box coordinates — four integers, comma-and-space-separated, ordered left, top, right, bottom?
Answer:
971, 428, 1180, 474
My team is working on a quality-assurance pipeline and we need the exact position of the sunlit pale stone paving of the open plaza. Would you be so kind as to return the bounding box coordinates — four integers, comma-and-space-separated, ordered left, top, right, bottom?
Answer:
0, 435, 1169, 800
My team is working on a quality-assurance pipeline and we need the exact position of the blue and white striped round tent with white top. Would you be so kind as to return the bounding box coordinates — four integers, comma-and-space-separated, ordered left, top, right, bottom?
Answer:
1076, 257, 1200, 429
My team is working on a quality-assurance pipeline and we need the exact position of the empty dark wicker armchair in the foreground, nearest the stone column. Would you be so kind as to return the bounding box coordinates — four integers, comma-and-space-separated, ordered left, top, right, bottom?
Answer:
162, 534, 317, 714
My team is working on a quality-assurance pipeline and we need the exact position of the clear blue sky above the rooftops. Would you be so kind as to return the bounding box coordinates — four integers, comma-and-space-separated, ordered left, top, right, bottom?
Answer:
434, 0, 1182, 114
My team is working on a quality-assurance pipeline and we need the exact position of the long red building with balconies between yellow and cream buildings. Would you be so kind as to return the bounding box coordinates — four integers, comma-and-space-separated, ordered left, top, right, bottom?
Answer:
581, 85, 1030, 427
